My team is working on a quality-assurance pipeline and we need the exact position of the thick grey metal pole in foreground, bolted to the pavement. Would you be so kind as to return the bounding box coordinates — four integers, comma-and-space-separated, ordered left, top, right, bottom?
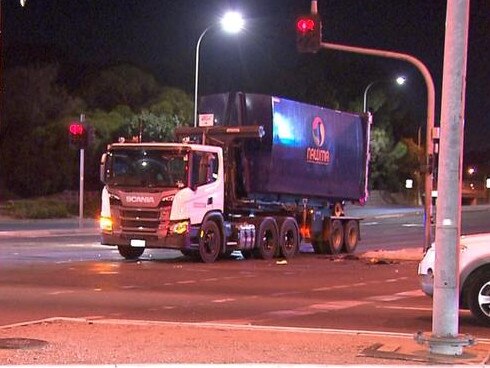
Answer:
428, 0, 470, 355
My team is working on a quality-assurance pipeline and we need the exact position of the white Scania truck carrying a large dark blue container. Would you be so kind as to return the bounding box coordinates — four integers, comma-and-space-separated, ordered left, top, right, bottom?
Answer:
100, 92, 371, 263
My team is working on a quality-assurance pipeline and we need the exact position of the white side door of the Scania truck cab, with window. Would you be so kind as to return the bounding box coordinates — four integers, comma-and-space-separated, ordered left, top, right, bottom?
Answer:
191, 151, 223, 224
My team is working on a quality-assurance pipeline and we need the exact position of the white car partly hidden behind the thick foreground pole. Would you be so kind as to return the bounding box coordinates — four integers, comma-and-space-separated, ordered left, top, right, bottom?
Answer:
418, 233, 490, 326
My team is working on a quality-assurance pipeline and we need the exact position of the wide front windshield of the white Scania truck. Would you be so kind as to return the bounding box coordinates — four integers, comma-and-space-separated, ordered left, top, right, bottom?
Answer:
106, 148, 187, 188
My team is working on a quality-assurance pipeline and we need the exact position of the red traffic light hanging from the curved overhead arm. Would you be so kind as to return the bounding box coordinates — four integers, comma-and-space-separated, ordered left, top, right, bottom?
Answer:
296, 14, 322, 52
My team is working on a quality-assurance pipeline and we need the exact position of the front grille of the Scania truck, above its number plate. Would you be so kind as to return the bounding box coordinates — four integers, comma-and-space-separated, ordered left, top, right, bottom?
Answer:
119, 207, 170, 237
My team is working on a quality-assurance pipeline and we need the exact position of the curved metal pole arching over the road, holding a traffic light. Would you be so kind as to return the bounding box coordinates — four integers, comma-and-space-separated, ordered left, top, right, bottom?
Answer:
320, 42, 435, 249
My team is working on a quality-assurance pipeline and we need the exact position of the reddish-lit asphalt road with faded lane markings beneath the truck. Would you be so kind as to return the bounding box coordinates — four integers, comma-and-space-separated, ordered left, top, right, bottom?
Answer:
0, 208, 490, 338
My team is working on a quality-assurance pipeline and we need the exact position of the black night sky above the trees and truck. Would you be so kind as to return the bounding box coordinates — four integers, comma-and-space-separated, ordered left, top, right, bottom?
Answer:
1, 0, 490, 150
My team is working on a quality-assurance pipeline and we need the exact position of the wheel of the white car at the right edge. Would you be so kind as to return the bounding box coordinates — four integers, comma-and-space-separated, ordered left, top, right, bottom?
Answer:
467, 268, 490, 326
